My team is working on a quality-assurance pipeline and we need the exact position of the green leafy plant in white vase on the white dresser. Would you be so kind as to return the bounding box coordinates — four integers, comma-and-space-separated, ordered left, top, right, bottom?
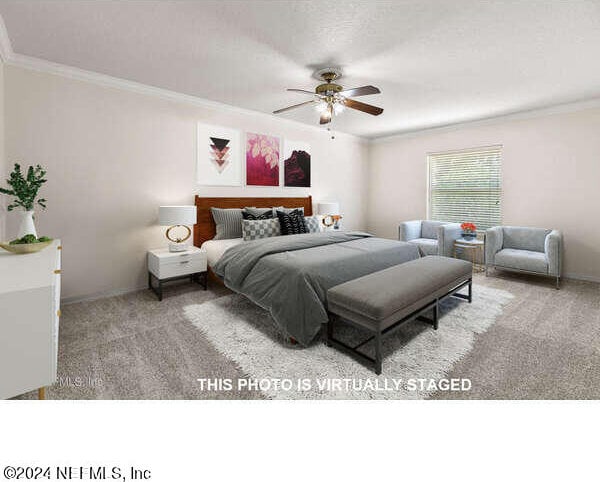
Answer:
0, 163, 52, 252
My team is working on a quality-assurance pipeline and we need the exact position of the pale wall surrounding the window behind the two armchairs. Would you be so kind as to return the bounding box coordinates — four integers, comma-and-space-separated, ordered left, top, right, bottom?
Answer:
368, 108, 600, 281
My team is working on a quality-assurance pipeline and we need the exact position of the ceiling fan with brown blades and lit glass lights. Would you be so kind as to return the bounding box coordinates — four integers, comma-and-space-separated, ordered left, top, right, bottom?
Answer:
273, 67, 383, 124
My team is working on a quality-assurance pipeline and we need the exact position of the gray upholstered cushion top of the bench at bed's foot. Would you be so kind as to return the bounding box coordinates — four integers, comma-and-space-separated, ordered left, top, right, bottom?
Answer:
327, 256, 472, 330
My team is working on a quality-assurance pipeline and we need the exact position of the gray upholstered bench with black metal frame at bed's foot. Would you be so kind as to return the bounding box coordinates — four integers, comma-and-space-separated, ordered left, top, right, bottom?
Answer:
324, 256, 472, 375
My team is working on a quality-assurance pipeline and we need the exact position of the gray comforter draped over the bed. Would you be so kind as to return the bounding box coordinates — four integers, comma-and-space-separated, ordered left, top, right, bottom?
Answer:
214, 232, 419, 346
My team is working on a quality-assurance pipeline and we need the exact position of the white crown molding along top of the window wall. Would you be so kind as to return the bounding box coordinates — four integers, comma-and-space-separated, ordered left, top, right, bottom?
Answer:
369, 98, 600, 144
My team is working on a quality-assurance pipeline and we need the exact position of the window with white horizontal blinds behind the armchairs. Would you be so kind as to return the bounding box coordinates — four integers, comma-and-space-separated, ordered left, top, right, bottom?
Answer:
427, 146, 502, 230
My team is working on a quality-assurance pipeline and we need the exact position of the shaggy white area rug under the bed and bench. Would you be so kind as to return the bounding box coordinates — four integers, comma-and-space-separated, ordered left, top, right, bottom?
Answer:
185, 285, 513, 399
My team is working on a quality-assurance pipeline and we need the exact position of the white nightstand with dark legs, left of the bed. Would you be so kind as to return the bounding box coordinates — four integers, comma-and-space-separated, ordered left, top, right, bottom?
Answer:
148, 246, 208, 301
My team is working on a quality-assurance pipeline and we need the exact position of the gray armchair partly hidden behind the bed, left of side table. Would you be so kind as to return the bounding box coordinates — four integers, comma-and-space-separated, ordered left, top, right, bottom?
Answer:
398, 220, 462, 257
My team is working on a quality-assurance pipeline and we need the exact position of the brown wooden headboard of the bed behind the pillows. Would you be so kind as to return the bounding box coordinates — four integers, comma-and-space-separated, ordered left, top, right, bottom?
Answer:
194, 196, 312, 247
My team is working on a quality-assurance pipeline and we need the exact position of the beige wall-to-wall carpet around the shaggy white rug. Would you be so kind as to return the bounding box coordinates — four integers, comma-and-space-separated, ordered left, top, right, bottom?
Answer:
12, 273, 600, 399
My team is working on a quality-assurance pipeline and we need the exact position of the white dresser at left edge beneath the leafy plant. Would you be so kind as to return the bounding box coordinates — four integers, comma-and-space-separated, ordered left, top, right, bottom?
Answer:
0, 240, 62, 399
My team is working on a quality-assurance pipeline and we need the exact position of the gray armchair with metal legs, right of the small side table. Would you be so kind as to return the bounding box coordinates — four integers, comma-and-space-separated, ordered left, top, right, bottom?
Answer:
485, 226, 563, 289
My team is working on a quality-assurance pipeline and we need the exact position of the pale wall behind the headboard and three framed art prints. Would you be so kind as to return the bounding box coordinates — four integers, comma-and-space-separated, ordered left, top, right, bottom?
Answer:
5, 66, 368, 299
